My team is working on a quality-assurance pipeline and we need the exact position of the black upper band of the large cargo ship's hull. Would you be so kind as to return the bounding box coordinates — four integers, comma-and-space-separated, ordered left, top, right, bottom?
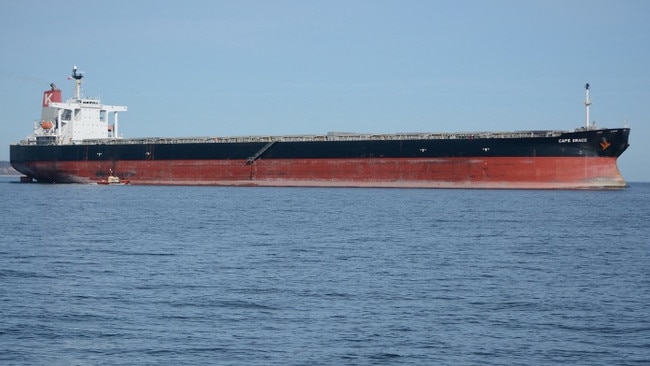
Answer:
10, 128, 630, 163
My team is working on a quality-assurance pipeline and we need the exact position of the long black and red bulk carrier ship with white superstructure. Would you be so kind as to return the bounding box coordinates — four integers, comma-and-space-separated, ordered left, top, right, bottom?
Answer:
10, 66, 630, 189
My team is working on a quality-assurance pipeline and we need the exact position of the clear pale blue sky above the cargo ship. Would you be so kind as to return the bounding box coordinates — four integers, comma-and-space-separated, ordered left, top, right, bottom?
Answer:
0, 0, 650, 182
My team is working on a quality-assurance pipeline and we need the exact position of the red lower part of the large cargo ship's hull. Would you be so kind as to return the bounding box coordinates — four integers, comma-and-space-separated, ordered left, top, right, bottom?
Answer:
12, 157, 626, 189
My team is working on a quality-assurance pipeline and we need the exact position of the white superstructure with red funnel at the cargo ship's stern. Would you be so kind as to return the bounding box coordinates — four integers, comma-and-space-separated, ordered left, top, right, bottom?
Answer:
29, 66, 127, 145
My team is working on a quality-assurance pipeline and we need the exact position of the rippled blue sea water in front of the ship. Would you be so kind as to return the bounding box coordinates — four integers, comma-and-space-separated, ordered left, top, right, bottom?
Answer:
0, 177, 650, 365
